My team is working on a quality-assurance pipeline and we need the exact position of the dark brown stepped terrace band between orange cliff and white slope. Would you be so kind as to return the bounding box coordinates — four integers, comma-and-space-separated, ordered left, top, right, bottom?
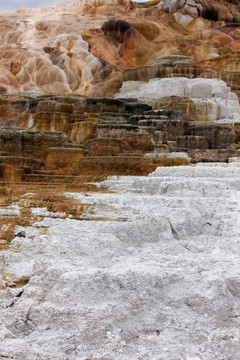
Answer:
0, 93, 239, 183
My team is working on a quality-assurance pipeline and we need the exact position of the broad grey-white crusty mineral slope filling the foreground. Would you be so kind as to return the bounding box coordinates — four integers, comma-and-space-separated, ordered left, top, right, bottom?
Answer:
0, 162, 240, 360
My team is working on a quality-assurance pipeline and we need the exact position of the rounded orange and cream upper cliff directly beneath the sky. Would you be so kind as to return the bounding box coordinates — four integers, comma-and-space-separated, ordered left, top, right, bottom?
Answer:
0, 0, 240, 96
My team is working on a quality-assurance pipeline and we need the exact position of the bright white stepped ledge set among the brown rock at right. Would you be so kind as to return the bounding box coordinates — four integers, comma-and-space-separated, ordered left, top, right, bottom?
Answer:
115, 77, 240, 122
